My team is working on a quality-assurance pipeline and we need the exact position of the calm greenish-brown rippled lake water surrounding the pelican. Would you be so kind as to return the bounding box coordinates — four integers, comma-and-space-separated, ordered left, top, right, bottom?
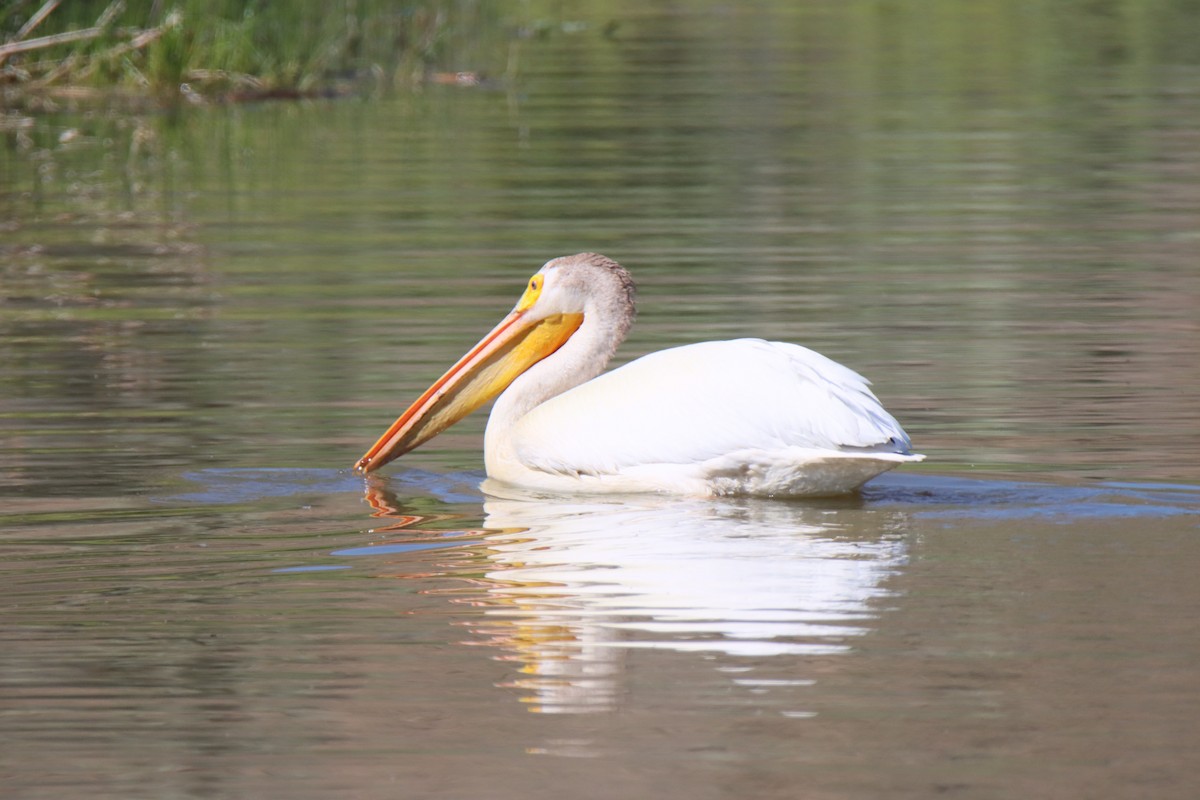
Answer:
0, 1, 1200, 800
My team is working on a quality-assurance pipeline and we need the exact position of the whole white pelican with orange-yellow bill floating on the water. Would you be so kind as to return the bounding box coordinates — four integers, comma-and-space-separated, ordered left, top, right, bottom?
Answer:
355, 253, 924, 497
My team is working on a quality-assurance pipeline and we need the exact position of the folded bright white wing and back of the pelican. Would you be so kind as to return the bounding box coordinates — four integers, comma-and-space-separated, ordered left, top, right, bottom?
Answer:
510, 339, 910, 475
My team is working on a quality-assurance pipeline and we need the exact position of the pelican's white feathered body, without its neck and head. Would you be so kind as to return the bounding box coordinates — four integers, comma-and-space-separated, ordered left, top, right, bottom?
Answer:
485, 339, 923, 495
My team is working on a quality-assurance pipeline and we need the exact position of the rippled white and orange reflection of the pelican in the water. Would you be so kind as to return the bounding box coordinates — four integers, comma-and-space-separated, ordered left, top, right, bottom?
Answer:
367, 479, 908, 714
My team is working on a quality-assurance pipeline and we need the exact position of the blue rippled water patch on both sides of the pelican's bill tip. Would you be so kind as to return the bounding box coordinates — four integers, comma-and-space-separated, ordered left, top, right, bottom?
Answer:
156, 468, 484, 505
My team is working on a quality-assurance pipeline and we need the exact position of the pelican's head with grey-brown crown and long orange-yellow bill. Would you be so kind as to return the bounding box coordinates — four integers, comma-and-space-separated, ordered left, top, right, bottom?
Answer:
354, 253, 634, 473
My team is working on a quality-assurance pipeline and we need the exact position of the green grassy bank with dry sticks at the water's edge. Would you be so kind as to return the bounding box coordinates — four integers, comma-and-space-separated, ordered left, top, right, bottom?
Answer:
0, 0, 480, 112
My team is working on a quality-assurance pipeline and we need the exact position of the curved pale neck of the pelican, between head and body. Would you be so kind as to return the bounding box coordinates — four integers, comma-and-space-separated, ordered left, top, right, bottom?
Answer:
484, 289, 634, 465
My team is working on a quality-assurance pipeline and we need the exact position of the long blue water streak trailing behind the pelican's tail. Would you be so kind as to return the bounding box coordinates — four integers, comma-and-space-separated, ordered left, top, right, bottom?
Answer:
863, 474, 1200, 524
